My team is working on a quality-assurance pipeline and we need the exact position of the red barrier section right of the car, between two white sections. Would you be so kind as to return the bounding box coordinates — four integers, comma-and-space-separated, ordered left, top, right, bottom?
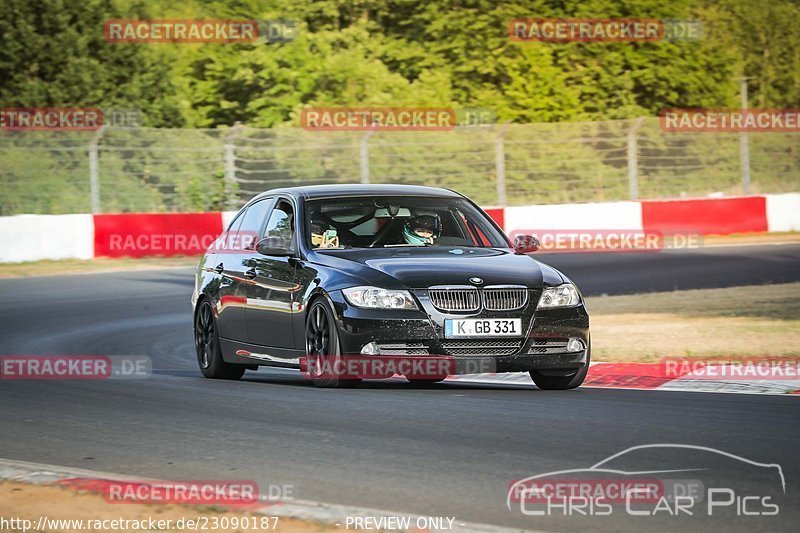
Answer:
641, 196, 767, 235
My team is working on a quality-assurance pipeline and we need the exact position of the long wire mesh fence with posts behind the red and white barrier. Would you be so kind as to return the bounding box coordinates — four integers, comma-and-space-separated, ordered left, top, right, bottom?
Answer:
0, 118, 800, 215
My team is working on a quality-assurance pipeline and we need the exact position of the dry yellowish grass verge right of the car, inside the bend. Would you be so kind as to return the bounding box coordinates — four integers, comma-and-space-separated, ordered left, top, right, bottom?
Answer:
586, 283, 800, 362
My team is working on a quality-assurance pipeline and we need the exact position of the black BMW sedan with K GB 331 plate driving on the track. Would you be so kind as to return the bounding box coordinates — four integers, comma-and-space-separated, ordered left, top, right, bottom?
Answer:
192, 185, 591, 389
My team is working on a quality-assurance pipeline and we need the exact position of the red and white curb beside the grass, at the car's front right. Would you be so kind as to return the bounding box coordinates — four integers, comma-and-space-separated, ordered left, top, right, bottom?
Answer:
445, 363, 800, 396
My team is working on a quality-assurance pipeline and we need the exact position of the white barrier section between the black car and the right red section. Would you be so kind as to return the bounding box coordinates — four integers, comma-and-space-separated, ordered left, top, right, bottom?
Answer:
505, 202, 642, 234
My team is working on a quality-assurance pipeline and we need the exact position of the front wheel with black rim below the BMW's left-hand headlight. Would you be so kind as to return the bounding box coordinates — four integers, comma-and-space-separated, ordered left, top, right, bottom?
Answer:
306, 298, 361, 388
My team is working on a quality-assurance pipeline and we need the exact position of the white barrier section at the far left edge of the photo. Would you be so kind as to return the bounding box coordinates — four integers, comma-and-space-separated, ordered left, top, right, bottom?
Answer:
0, 215, 94, 263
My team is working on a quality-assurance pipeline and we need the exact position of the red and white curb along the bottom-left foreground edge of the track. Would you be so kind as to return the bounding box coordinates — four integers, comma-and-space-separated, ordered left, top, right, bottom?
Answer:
0, 459, 531, 533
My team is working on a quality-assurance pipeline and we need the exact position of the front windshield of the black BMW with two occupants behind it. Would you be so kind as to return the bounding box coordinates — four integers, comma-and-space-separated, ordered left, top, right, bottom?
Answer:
306, 196, 509, 249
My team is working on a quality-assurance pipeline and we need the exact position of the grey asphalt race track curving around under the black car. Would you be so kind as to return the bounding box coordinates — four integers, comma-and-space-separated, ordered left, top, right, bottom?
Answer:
0, 245, 800, 531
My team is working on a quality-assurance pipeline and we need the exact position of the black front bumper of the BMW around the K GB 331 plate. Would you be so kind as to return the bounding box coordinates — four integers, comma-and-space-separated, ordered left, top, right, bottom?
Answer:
330, 291, 591, 374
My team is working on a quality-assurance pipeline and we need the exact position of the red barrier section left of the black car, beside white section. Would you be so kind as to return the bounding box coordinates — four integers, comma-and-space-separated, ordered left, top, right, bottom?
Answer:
94, 212, 222, 257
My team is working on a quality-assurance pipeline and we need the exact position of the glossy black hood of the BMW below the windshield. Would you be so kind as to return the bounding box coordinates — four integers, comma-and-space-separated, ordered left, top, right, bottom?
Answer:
309, 246, 564, 289
